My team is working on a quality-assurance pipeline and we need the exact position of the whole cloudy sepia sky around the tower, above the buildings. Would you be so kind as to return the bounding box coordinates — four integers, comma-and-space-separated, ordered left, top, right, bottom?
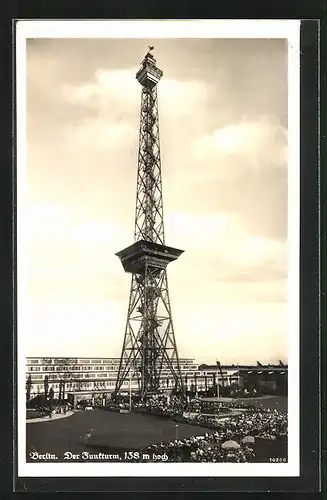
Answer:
21, 39, 288, 363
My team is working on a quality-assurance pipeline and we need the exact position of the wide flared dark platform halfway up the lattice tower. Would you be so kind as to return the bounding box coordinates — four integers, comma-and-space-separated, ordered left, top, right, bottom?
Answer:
116, 240, 184, 274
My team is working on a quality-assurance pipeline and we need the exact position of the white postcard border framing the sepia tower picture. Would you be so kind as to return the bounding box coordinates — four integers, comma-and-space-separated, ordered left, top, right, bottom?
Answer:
16, 20, 300, 477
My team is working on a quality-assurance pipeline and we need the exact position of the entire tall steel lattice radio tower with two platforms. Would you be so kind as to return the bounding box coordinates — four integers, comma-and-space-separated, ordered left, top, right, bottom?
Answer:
115, 46, 184, 401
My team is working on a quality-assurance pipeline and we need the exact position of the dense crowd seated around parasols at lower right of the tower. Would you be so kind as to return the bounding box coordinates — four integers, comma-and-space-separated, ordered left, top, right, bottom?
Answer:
129, 396, 287, 462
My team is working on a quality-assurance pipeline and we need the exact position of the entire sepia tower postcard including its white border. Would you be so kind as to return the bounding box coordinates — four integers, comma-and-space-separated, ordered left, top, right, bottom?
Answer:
16, 21, 299, 477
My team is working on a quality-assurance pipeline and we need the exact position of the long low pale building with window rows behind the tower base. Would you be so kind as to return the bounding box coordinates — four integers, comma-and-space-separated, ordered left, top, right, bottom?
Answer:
26, 357, 287, 400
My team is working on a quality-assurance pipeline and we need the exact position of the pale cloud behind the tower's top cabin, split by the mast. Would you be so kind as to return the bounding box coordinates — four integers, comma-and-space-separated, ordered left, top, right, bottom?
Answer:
60, 69, 211, 149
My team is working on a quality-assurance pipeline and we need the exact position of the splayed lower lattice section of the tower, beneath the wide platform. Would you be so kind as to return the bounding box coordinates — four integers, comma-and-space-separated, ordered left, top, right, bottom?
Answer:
116, 266, 183, 393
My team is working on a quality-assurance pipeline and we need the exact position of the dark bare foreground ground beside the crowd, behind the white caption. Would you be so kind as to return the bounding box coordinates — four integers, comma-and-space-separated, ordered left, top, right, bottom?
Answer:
26, 399, 286, 463
